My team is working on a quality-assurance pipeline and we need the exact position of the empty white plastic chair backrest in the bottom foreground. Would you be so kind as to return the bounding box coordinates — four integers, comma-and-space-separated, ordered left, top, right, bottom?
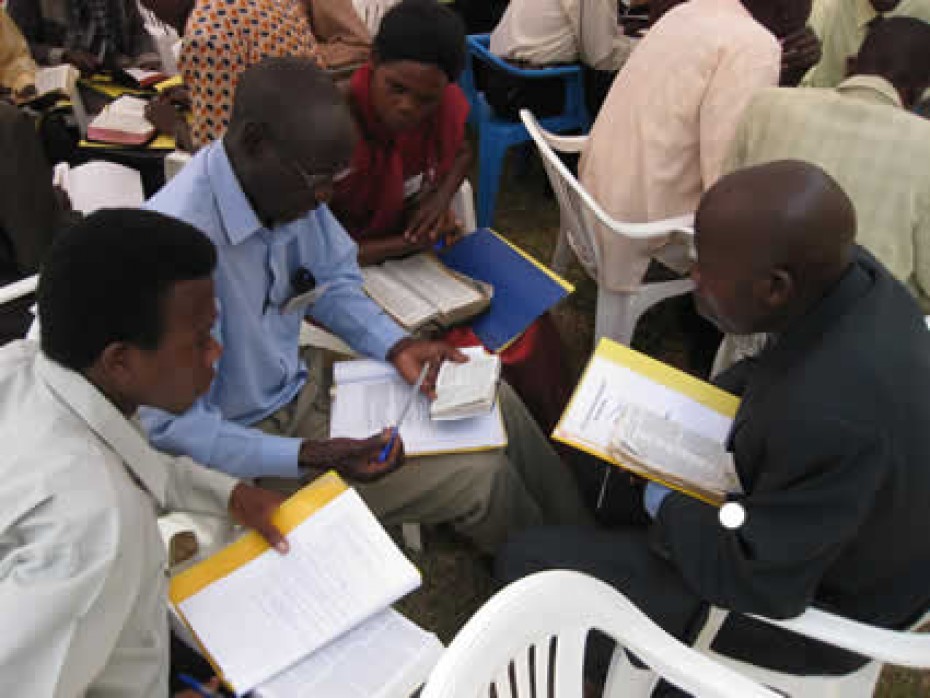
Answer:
421, 570, 777, 698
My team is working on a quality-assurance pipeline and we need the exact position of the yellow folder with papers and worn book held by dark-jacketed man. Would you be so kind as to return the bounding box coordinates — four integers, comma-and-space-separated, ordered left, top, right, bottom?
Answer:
552, 339, 741, 505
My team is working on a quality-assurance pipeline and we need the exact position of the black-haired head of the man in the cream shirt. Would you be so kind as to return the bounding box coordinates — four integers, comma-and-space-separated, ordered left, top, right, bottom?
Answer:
38, 209, 219, 411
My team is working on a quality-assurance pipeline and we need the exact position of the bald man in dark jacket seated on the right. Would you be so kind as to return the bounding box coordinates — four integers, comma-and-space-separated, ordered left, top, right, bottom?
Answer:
500, 162, 930, 674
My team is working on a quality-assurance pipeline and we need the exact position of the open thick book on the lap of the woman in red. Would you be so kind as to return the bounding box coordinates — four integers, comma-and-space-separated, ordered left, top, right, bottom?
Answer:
362, 252, 494, 332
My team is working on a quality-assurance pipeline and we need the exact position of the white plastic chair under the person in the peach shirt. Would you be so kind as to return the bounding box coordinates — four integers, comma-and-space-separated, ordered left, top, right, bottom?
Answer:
520, 109, 694, 345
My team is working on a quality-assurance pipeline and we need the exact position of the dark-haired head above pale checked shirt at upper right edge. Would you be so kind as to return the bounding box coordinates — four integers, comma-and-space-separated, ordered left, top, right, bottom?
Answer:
849, 17, 930, 108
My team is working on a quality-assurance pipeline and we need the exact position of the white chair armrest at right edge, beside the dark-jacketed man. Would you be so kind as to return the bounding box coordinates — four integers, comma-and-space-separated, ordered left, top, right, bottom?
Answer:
751, 608, 930, 669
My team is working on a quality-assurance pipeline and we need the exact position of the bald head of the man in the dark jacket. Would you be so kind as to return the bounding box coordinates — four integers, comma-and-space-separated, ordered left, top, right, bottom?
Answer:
694, 160, 856, 334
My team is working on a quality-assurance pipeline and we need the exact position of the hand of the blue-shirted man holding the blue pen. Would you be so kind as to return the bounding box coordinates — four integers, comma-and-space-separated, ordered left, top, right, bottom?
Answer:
297, 429, 404, 483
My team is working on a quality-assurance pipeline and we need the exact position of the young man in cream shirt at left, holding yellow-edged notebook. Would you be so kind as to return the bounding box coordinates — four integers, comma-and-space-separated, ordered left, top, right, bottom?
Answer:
0, 210, 287, 698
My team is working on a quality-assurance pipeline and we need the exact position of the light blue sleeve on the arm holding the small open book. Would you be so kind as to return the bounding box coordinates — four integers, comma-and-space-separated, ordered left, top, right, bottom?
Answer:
307, 206, 407, 359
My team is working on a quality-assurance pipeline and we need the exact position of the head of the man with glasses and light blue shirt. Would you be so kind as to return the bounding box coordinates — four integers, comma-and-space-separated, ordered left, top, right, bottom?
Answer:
223, 57, 356, 225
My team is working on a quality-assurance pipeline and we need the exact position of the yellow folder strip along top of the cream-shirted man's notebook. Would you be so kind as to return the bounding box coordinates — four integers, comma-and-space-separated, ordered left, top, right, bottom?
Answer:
168, 471, 348, 606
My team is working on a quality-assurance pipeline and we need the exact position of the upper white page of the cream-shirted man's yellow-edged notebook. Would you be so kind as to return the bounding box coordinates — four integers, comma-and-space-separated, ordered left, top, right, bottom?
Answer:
179, 490, 420, 693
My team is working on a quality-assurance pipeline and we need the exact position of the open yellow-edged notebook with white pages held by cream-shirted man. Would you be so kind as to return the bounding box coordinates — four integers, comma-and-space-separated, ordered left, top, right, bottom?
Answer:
169, 473, 441, 698
